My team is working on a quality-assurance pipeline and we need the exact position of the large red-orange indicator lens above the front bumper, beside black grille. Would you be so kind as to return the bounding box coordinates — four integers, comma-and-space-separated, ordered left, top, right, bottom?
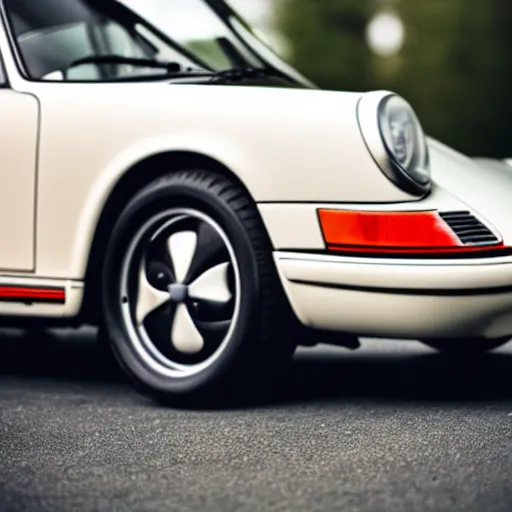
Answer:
318, 210, 504, 253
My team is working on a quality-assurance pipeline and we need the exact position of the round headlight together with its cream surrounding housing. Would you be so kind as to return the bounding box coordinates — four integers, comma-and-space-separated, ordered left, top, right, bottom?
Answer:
358, 92, 431, 195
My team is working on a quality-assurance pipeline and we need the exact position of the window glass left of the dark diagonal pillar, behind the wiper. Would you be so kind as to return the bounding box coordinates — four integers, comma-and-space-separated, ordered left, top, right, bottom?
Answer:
4, 0, 171, 82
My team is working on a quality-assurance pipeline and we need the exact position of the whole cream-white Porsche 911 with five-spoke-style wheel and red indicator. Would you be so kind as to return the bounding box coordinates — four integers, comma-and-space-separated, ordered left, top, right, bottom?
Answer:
0, 0, 512, 400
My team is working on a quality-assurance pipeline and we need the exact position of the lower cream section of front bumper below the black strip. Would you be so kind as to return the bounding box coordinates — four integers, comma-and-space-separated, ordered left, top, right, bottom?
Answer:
276, 280, 512, 339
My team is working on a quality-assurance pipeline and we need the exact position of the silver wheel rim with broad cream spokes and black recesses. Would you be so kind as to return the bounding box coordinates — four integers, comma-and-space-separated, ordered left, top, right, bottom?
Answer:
120, 209, 240, 378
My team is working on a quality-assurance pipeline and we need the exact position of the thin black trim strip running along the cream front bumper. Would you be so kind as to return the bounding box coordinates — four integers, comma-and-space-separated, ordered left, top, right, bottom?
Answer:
289, 279, 512, 297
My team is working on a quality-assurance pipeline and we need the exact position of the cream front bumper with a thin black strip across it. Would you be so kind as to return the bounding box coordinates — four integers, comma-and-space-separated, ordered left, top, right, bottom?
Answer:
274, 251, 512, 339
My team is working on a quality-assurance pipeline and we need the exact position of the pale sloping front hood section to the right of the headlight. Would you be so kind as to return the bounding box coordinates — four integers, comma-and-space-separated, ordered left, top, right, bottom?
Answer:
428, 139, 512, 245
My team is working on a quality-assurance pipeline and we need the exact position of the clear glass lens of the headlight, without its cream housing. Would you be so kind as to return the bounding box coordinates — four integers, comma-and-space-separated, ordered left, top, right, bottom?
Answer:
379, 96, 430, 185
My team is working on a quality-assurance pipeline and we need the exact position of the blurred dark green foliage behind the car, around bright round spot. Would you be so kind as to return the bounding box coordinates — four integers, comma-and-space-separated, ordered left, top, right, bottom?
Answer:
275, 0, 512, 157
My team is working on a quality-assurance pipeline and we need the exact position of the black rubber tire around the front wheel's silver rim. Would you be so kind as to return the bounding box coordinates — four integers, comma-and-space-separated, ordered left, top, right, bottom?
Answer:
102, 171, 296, 405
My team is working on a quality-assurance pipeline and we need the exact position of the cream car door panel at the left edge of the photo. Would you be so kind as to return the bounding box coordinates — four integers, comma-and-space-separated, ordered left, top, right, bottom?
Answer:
0, 55, 39, 272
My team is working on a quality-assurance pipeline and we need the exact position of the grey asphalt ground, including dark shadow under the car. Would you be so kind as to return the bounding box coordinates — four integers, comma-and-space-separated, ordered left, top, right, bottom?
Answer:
0, 331, 512, 512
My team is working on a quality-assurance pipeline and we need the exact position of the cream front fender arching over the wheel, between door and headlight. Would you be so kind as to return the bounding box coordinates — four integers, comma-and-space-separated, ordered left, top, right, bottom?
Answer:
7, 83, 417, 279
